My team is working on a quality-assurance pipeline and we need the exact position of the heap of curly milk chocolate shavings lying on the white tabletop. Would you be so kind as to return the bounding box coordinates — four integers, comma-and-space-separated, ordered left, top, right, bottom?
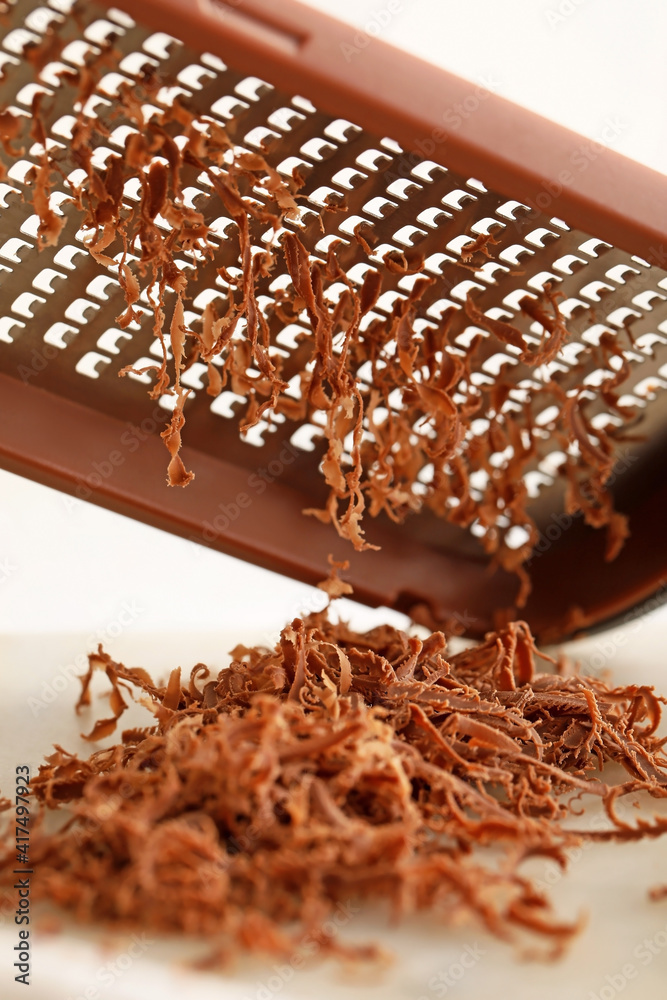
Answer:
0, 612, 667, 962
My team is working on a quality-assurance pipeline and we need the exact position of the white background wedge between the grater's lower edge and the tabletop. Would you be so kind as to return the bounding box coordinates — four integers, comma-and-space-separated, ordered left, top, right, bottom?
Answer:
0, 464, 406, 638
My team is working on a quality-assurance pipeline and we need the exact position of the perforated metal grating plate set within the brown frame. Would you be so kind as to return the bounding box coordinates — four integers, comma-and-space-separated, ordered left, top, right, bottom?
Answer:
0, 0, 667, 592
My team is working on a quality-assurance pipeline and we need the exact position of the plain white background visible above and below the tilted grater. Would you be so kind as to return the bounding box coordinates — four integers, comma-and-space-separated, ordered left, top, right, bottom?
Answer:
0, 0, 667, 640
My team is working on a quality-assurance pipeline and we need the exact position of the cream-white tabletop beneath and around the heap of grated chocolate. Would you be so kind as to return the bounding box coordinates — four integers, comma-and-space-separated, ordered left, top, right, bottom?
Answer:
0, 614, 667, 1000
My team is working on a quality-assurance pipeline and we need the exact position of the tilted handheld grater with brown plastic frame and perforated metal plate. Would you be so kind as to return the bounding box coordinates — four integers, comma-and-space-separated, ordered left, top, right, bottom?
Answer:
0, 0, 667, 641
